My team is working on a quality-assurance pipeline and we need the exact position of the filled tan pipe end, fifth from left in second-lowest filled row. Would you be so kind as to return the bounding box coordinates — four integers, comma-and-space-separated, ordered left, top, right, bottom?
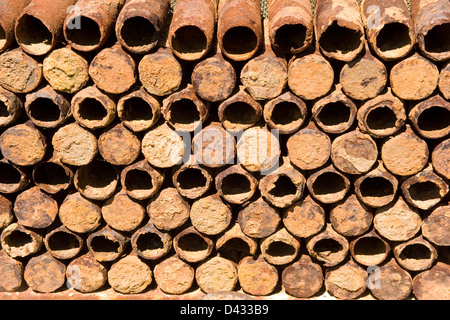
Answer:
147, 187, 190, 231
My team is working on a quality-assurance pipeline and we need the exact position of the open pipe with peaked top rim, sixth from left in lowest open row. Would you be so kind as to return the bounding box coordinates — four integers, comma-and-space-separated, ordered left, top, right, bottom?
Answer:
216, 222, 258, 263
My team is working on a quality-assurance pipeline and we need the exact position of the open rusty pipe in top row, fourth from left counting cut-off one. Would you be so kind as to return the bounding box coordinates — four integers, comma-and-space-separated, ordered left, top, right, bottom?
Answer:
115, 0, 170, 54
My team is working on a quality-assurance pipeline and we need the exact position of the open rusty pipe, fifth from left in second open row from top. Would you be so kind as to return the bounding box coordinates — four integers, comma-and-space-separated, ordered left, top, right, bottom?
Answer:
161, 84, 209, 132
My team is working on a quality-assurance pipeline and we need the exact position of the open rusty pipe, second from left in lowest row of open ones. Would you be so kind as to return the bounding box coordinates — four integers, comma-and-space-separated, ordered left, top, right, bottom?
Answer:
44, 226, 84, 260
